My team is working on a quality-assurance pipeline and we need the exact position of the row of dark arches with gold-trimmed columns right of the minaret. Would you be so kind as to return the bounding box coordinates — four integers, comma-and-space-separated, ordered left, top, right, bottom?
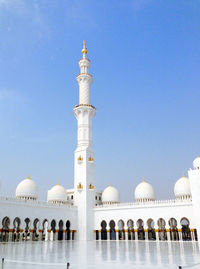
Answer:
94, 217, 197, 241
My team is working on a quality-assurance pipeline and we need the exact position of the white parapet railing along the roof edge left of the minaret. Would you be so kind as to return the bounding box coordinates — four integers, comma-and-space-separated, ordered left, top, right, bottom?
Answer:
0, 196, 76, 208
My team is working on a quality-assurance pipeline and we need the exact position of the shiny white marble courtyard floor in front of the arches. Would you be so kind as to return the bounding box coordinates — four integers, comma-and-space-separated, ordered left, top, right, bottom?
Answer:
0, 241, 200, 269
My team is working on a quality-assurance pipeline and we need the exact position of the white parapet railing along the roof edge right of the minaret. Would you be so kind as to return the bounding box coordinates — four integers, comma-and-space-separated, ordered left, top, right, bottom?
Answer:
95, 198, 192, 208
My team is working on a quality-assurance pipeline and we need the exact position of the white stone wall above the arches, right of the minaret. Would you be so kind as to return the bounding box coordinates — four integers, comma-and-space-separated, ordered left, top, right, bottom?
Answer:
94, 200, 196, 230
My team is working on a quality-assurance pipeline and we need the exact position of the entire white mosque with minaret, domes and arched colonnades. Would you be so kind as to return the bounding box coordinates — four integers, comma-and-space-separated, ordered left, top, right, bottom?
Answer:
0, 43, 200, 242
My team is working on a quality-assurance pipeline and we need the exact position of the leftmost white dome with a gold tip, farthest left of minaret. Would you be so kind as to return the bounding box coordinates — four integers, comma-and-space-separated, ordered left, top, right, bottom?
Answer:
16, 177, 38, 200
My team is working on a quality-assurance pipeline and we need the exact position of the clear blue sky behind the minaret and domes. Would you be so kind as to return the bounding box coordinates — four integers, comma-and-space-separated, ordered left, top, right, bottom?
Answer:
0, 0, 200, 201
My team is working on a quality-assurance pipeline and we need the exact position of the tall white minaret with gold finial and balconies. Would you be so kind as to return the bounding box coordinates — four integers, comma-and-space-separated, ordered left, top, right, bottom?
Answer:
74, 42, 96, 240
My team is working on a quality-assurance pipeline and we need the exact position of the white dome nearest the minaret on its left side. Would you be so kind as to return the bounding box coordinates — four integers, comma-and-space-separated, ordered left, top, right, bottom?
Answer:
47, 183, 67, 203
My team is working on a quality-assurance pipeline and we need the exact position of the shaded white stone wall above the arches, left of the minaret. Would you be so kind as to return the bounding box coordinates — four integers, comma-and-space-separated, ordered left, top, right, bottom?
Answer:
0, 197, 77, 230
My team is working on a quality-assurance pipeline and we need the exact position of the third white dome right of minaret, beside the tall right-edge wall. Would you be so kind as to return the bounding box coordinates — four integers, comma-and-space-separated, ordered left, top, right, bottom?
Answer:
174, 174, 191, 199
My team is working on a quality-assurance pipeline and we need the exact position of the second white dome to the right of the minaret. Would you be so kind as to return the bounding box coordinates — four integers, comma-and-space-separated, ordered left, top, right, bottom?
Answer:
135, 179, 155, 202
